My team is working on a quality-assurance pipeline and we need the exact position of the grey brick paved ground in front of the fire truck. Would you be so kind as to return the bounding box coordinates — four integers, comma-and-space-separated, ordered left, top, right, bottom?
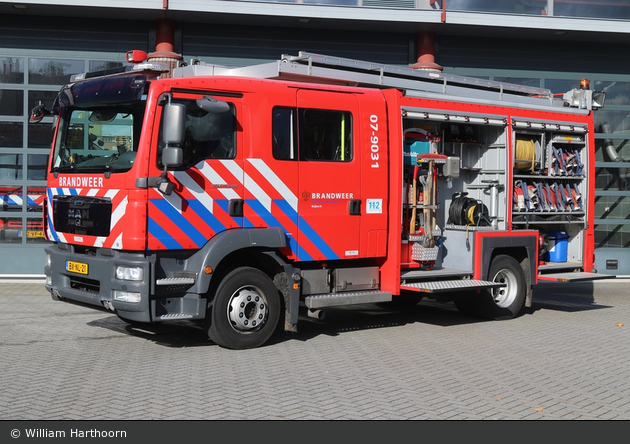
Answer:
0, 280, 630, 420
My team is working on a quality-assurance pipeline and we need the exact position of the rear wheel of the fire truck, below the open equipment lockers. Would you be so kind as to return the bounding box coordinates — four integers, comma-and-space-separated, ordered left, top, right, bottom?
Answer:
473, 254, 527, 320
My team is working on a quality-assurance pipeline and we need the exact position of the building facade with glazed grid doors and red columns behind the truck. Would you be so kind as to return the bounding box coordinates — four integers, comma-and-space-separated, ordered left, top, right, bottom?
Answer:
0, 0, 630, 276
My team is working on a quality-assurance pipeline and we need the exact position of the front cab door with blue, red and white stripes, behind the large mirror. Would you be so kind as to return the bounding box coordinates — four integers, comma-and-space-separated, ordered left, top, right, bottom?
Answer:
148, 93, 243, 250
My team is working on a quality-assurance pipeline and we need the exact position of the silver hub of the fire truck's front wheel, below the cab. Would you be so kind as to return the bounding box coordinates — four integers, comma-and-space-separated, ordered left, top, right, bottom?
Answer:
227, 286, 269, 333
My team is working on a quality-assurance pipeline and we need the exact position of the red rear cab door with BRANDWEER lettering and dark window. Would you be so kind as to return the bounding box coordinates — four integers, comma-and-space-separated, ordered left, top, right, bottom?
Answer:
297, 89, 365, 260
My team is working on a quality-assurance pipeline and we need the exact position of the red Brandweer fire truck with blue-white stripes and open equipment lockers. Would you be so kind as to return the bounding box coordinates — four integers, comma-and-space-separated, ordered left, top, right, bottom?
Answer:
31, 51, 611, 349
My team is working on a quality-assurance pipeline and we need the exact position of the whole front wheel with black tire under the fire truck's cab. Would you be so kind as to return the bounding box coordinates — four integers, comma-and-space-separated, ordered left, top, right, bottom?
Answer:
207, 267, 282, 350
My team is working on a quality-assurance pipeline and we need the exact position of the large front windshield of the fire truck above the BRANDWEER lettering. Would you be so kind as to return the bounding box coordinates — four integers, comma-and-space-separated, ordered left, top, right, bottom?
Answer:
53, 102, 145, 173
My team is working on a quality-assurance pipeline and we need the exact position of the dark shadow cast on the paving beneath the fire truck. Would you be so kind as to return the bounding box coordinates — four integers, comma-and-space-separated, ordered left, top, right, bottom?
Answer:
88, 282, 609, 348
